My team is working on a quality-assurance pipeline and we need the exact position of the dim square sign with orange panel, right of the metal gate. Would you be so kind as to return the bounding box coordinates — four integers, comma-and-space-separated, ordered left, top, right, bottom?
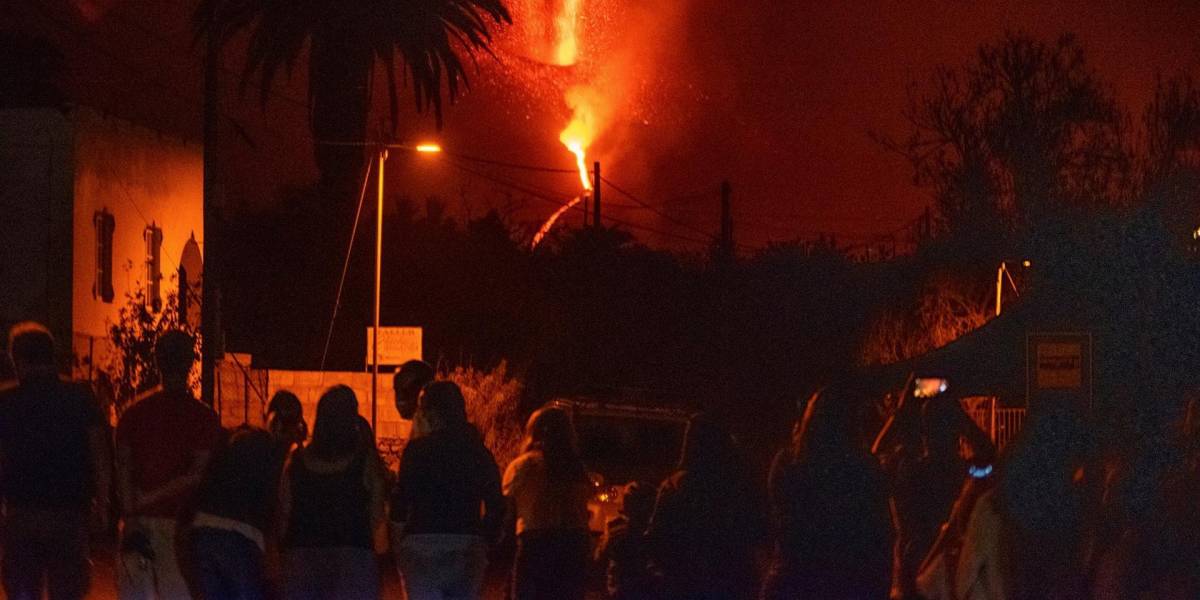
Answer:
1025, 332, 1092, 408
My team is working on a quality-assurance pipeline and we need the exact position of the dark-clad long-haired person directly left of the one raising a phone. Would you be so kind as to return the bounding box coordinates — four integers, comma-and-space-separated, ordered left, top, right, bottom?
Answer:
762, 384, 892, 600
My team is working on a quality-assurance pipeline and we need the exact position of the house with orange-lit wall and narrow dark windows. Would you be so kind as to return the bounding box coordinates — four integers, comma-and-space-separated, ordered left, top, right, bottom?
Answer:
0, 108, 204, 377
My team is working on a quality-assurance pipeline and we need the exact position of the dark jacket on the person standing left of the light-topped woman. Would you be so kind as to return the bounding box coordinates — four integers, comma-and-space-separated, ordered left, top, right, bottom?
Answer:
391, 426, 505, 538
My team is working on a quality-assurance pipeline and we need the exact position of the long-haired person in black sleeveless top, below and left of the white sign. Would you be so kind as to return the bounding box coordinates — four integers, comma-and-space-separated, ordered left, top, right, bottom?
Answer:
280, 385, 384, 599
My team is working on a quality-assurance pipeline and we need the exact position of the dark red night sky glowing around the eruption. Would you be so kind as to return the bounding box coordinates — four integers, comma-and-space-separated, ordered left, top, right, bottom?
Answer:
9, 0, 1200, 248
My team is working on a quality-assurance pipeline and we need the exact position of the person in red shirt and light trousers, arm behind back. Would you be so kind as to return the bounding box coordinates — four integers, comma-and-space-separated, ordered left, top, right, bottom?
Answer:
116, 330, 221, 600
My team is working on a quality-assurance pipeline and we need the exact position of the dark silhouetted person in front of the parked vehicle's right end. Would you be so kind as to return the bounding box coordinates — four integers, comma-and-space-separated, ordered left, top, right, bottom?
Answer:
646, 415, 766, 600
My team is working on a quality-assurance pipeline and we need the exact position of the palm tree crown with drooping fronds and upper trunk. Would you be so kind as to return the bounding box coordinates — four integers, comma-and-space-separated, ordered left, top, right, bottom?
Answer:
192, 0, 512, 193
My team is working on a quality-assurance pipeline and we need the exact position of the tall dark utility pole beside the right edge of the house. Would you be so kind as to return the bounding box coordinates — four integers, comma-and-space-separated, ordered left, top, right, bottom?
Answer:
200, 28, 222, 407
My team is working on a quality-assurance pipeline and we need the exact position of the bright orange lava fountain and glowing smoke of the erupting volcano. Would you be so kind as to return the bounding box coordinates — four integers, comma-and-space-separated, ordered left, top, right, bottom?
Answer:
496, 0, 680, 245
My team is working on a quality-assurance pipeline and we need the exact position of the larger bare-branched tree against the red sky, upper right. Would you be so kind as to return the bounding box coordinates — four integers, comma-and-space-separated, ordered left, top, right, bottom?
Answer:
877, 29, 1133, 244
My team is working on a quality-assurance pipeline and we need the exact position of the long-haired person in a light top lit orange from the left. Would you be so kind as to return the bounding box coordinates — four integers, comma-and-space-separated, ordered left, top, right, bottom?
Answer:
504, 407, 592, 600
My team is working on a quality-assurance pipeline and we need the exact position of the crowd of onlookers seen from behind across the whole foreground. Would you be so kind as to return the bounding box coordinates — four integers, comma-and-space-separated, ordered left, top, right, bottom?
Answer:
0, 323, 1200, 600
